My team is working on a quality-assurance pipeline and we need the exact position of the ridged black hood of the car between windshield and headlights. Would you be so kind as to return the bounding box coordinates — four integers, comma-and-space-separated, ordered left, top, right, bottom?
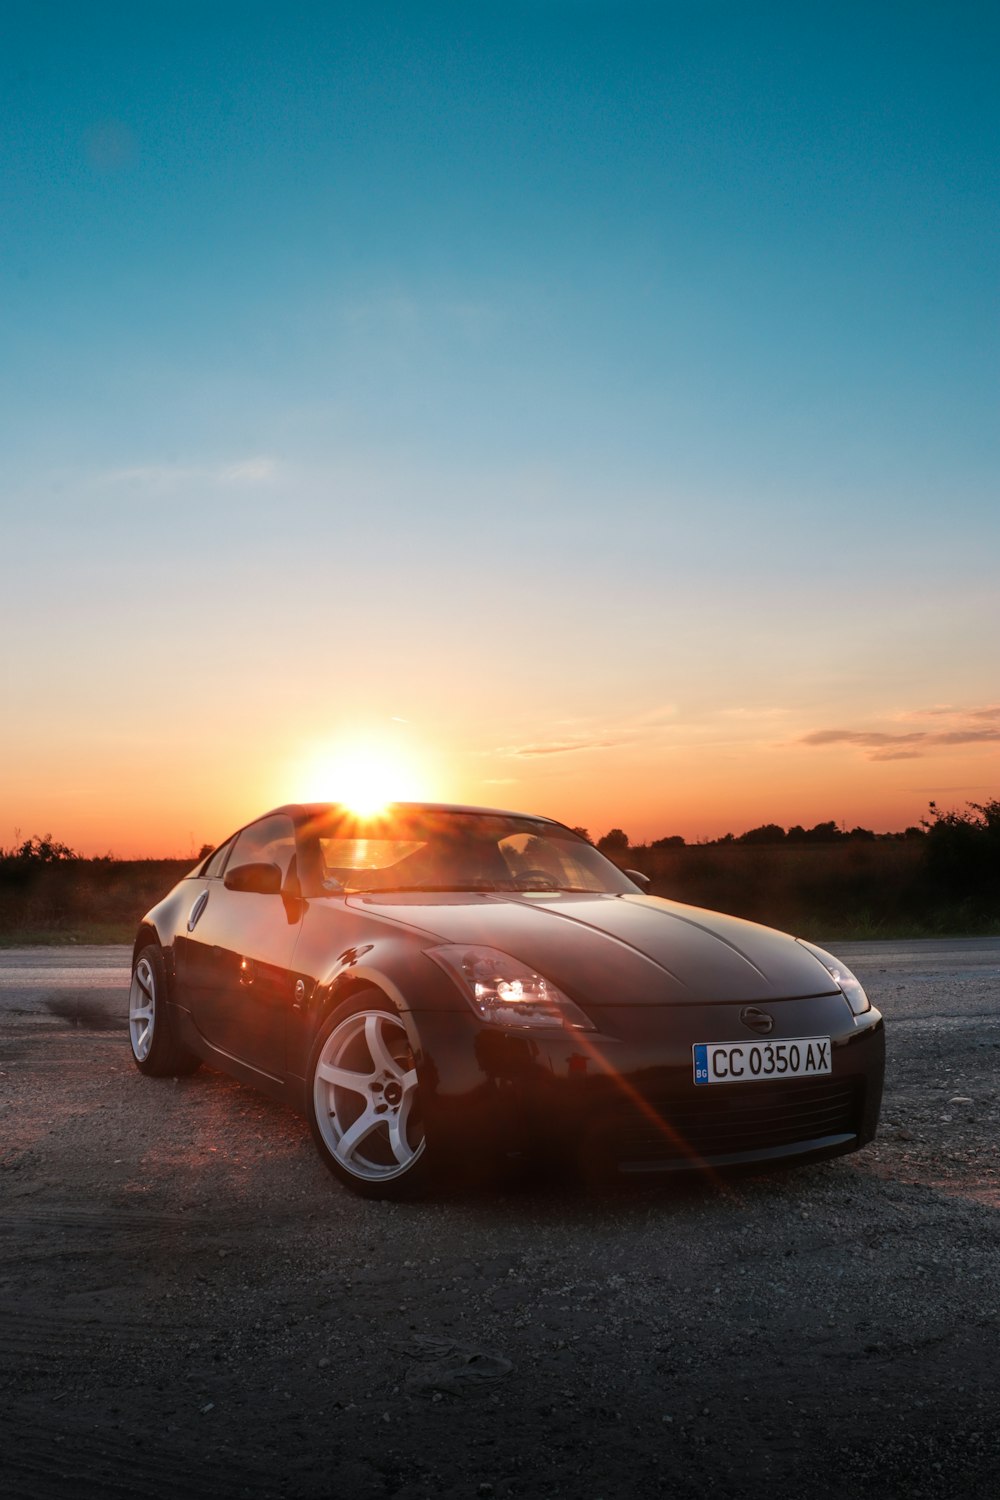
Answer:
348, 891, 840, 1005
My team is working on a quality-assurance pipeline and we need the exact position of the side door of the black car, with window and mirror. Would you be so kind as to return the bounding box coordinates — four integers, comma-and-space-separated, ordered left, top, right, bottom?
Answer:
186, 813, 303, 1079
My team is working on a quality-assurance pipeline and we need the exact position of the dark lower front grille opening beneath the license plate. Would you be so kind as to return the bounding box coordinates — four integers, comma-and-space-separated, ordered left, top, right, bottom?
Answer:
600, 1079, 861, 1166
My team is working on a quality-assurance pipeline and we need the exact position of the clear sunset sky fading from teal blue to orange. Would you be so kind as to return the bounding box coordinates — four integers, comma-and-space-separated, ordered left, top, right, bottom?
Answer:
0, 0, 1000, 843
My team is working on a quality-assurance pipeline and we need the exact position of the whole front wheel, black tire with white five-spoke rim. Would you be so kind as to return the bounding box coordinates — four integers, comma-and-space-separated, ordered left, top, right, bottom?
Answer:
307, 989, 430, 1199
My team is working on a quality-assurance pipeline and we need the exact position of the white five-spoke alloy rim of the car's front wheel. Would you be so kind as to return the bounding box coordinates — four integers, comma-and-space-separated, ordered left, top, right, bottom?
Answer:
312, 1010, 424, 1184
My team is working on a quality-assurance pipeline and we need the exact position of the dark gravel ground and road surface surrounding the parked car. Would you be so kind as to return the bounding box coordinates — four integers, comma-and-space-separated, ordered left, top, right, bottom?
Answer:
0, 939, 1000, 1500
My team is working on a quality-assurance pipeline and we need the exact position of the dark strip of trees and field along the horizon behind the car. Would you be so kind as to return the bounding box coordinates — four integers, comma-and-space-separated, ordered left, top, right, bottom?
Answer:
0, 800, 1000, 942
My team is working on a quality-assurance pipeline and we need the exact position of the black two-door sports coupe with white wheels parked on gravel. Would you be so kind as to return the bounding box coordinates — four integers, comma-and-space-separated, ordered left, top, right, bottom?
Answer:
129, 803, 885, 1197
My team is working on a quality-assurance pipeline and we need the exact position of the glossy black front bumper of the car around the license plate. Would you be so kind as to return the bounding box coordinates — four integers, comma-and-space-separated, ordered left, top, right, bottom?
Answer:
414, 1002, 885, 1173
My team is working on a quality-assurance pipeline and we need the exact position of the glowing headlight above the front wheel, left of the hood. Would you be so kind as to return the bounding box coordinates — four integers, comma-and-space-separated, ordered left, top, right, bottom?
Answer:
427, 944, 594, 1031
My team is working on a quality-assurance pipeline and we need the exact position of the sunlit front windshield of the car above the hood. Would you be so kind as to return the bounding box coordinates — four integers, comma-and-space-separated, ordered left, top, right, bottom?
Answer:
310, 809, 636, 894
